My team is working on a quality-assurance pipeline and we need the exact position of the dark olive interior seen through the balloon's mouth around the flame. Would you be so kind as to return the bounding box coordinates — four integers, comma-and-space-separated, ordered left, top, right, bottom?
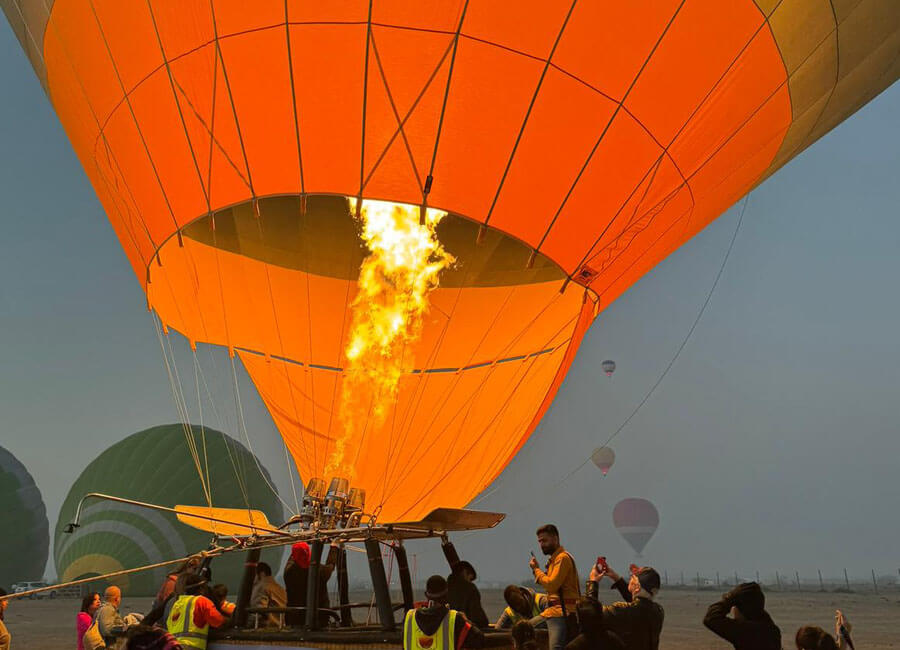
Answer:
174, 194, 566, 288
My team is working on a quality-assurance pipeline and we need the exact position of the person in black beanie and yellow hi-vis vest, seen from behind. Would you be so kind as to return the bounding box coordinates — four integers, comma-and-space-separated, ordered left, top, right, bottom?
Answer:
403, 576, 484, 650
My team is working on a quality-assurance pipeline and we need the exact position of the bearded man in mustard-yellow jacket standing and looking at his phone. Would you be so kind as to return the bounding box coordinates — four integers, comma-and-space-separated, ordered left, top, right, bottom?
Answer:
528, 524, 580, 650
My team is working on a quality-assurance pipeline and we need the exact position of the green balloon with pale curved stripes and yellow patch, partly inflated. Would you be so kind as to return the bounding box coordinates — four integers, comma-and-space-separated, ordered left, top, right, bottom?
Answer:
54, 424, 283, 595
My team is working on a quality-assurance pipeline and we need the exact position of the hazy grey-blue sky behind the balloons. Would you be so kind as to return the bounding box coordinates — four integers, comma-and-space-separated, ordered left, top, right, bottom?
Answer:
0, 21, 900, 580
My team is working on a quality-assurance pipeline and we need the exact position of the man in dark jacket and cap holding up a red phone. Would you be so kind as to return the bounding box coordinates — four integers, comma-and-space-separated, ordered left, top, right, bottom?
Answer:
587, 564, 665, 650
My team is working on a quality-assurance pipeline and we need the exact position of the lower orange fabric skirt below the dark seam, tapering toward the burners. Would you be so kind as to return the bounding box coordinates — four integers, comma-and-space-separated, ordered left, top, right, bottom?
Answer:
241, 336, 571, 521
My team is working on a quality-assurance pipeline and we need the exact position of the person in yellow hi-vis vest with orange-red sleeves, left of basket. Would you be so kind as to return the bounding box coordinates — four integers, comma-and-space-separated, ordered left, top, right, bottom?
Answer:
164, 573, 228, 650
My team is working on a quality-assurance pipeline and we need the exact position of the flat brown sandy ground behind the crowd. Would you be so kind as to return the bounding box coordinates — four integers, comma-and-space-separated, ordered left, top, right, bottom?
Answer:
6, 589, 900, 650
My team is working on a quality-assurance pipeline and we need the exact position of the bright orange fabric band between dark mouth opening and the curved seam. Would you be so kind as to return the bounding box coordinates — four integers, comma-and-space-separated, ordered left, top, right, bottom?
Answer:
150, 235, 580, 368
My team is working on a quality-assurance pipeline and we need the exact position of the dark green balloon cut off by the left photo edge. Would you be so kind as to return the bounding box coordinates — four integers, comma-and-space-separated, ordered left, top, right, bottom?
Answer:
0, 447, 50, 590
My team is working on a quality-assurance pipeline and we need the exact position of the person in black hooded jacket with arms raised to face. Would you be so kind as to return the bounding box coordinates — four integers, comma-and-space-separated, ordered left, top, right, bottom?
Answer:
703, 582, 781, 650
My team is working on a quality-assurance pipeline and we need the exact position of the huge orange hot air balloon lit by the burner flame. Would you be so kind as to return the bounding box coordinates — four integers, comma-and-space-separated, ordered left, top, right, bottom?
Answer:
2, 0, 900, 519
